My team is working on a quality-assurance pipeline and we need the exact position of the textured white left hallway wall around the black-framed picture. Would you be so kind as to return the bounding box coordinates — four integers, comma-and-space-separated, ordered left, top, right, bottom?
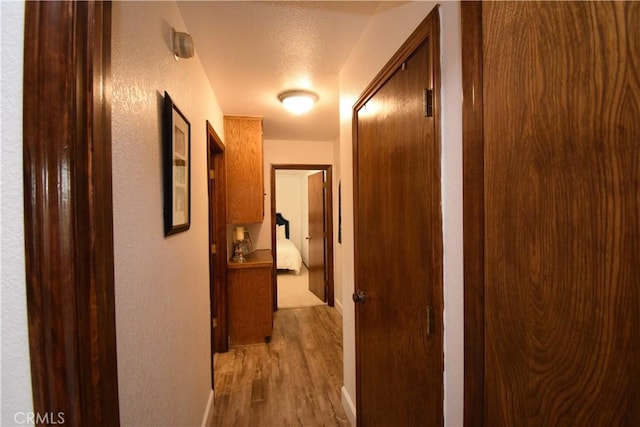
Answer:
112, 1, 224, 426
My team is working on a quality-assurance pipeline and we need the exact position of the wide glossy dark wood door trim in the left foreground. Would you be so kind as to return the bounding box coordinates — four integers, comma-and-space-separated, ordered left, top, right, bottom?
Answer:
23, 1, 120, 426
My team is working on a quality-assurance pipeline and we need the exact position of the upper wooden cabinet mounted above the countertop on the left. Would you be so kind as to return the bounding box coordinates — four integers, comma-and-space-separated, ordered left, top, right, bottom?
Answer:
224, 116, 264, 224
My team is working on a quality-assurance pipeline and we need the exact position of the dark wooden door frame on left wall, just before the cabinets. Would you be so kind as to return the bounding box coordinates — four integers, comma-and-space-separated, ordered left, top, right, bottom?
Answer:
206, 120, 229, 358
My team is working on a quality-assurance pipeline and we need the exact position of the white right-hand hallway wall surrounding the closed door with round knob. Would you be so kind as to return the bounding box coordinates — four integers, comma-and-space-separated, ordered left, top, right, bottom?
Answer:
336, 1, 463, 426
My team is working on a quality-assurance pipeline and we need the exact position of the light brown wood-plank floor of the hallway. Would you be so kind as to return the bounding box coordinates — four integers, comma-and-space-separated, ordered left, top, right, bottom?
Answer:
210, 305, 349, 427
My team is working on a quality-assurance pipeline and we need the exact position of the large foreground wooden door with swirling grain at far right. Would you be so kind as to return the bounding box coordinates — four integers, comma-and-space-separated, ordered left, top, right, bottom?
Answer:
465, 2, 640, 426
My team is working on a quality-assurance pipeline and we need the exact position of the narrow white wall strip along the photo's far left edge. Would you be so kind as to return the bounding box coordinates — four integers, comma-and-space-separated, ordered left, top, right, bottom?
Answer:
0, 2, 33, 426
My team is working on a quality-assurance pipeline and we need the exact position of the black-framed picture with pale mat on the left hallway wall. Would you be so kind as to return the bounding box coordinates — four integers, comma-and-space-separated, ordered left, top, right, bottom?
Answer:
162, 92, 191, 236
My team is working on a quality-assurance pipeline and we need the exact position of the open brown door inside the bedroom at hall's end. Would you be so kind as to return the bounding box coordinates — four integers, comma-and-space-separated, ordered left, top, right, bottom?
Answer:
307, 172, 327, 301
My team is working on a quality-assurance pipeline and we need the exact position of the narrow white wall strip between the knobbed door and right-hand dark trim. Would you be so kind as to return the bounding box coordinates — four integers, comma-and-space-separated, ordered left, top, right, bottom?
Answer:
440, 2, 464, 426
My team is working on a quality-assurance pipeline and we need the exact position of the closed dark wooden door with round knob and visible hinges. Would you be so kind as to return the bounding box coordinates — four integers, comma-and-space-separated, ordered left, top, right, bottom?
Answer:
354, 10, 443, 426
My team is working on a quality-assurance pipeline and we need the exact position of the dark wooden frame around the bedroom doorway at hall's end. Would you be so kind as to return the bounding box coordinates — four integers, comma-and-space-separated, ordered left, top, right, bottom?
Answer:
270, 164, 335, 311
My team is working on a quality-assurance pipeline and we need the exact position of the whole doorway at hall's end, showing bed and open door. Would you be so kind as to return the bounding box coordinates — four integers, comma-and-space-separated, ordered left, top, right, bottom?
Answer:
271, 165, 335, 311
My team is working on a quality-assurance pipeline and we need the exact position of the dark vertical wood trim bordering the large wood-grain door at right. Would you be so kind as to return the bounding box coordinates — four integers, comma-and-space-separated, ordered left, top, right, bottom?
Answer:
461, 2, 485, 427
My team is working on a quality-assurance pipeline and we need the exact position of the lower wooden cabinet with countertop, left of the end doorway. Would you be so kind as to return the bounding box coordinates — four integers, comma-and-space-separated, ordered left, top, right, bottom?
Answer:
227, 250, 273, 347
